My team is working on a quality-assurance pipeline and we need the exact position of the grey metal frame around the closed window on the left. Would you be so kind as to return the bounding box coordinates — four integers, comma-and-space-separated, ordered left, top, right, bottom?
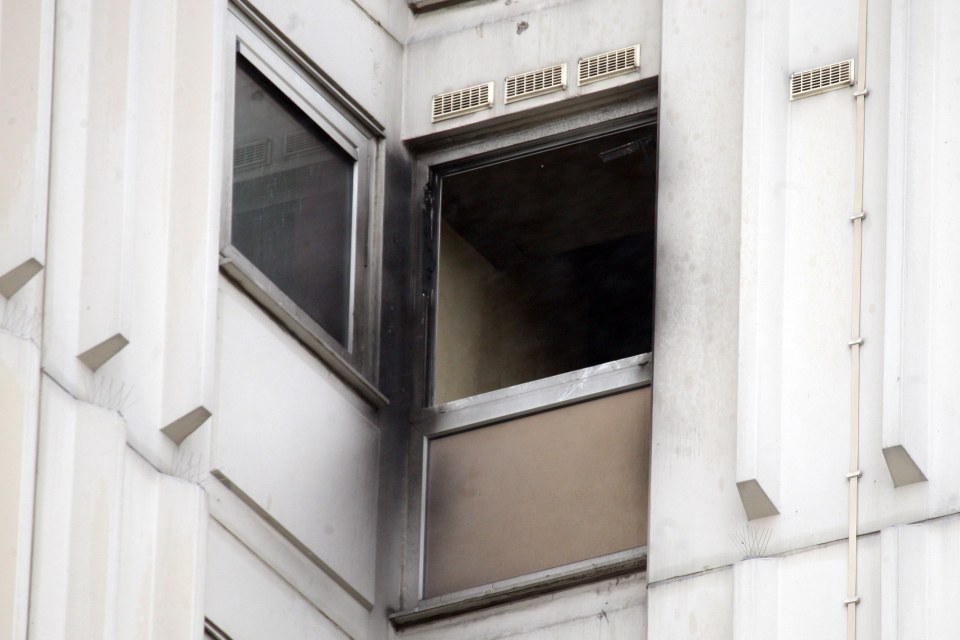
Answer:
220, 2, 388, 407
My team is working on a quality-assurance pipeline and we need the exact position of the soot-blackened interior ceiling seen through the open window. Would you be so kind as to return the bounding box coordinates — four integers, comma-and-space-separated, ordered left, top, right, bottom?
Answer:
441, 124, 657, 269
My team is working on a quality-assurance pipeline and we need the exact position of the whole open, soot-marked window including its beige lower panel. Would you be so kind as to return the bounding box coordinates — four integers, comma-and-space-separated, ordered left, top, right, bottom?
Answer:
394, 116, 657, 625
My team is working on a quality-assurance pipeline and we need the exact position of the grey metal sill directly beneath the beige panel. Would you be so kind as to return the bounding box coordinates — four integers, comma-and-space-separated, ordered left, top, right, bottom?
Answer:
389, 547, 647, 629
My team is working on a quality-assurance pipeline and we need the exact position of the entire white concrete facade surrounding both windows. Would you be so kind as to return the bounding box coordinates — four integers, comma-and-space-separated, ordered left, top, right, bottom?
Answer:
0, 0, 960, 640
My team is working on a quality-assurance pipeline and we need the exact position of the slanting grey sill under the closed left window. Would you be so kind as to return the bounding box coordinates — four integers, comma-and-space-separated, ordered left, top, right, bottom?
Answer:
220, 252, 390, 409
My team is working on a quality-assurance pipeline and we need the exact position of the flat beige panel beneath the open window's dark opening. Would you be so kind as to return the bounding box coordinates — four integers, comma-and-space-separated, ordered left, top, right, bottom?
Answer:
424, 387, 650, 598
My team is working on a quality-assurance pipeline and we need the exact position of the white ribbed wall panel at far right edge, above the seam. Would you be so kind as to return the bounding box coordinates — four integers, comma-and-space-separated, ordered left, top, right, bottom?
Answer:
882, 0, 960, 496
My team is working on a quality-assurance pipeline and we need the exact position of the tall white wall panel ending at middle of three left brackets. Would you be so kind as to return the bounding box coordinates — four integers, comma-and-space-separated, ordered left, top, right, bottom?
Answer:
44, 0, 132, 380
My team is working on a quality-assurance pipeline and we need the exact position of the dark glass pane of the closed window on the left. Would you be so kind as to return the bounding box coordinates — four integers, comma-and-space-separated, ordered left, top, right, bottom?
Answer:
231, 56, 354, 346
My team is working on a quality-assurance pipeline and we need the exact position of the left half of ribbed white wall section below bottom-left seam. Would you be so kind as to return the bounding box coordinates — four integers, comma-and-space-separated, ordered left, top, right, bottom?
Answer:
30, 377, 125, 639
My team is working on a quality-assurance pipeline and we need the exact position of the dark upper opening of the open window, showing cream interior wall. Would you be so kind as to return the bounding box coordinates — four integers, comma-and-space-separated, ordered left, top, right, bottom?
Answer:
433, 124, 657, 404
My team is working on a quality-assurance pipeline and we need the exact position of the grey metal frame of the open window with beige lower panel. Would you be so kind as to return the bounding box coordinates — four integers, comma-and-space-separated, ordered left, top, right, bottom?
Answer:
398, 97, 658, 628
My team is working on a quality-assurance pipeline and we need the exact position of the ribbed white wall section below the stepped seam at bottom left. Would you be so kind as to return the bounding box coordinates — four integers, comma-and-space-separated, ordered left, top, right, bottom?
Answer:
30, 377, 206, 640
